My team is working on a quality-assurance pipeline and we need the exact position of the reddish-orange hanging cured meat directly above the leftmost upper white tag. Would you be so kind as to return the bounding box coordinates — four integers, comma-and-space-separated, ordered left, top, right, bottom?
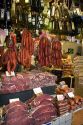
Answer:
2, 33, 17, 73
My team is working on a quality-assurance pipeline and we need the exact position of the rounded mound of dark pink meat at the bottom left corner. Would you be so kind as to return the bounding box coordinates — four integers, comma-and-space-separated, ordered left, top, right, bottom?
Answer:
5, 101, 34, 125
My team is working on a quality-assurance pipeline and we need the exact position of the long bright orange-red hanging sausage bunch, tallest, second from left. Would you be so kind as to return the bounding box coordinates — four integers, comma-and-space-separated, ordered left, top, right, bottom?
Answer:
18, 29, 34, 68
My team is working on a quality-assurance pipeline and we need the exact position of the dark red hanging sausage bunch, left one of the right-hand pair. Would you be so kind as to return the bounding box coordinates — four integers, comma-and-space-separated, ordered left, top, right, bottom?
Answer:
38, 37, 51, 66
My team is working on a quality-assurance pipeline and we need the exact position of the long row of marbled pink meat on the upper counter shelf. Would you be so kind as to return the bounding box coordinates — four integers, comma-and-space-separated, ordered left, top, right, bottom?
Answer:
0, 71, 57, 94
